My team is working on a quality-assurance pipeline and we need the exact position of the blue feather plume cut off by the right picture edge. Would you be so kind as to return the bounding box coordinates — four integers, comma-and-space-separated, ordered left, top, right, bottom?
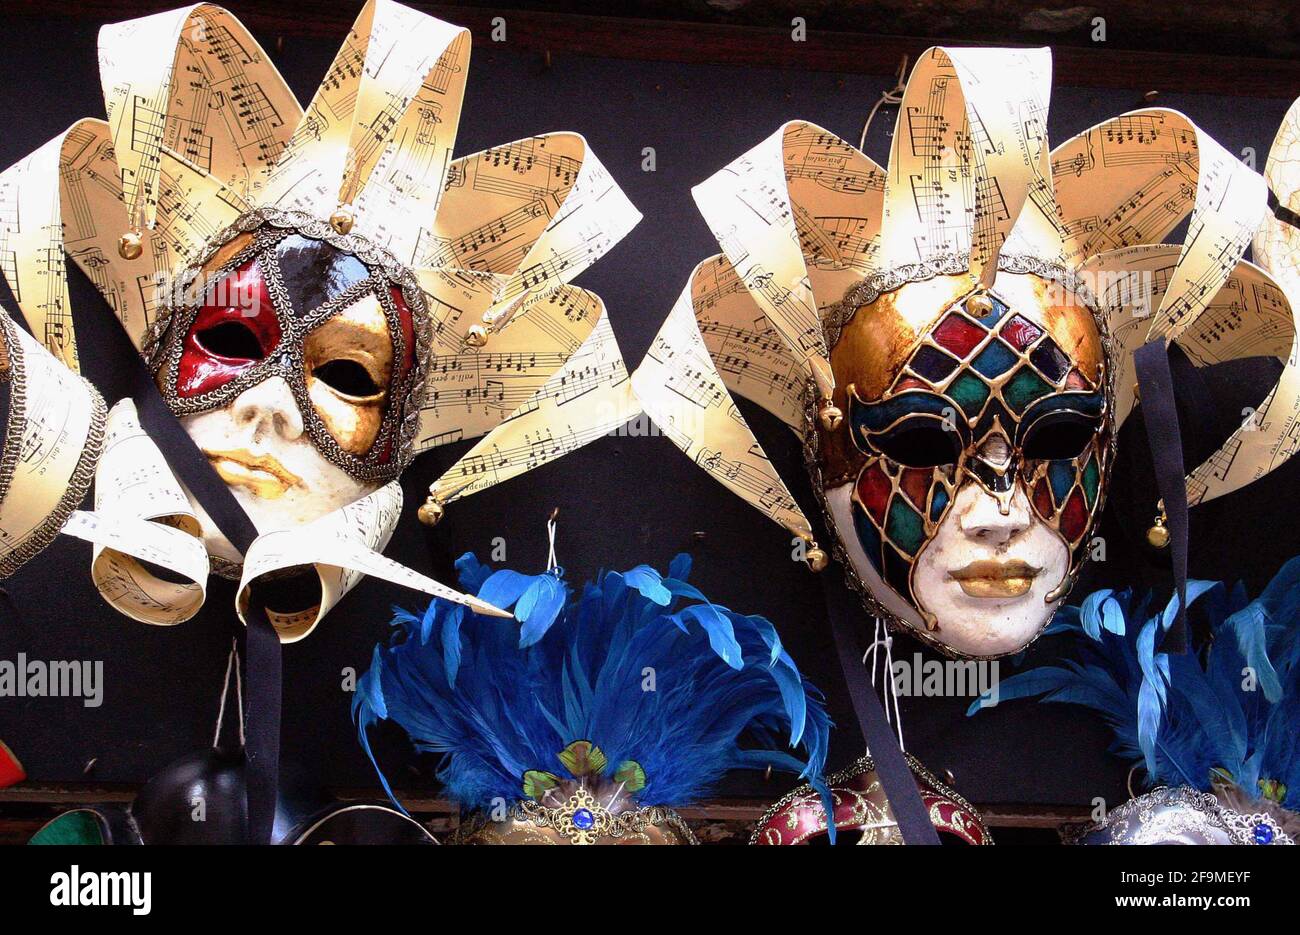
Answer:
967, 558, 1300, 810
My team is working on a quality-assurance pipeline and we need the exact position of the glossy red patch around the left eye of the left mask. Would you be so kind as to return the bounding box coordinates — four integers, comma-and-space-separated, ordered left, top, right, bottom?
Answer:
176, 260, 281, 399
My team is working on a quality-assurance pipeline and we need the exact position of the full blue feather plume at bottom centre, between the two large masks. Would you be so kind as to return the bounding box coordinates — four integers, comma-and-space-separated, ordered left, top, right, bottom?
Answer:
352, 554, 831, 808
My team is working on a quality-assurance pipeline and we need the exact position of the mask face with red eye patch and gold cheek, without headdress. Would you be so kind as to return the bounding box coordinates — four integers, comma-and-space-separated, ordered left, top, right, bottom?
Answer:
147, 209, 426, 556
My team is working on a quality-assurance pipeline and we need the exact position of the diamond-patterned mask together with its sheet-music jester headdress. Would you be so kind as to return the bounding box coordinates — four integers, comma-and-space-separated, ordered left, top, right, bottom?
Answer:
633, 48, 1300, 657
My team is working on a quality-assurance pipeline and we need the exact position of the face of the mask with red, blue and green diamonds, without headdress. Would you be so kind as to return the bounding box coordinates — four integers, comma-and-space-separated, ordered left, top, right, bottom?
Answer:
820, 270, 1113, 657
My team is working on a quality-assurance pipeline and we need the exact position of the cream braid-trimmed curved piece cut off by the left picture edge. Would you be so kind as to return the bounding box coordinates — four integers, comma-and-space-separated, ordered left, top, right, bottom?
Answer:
0, 309, 105, 579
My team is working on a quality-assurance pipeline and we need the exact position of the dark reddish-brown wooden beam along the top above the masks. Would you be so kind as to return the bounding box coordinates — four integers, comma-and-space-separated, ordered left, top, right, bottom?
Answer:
5, 0, 1300, 99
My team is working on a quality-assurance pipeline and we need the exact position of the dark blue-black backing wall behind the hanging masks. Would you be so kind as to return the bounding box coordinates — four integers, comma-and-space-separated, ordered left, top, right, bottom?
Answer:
0, 5, 1300, 806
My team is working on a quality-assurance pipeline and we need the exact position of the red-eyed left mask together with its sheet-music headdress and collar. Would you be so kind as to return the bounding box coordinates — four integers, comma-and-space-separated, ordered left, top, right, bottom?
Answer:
0, 0, 640, 636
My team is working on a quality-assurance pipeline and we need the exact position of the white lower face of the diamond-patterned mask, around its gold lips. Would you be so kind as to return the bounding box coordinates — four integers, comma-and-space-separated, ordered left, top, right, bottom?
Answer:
827, 482, 1070, 657
